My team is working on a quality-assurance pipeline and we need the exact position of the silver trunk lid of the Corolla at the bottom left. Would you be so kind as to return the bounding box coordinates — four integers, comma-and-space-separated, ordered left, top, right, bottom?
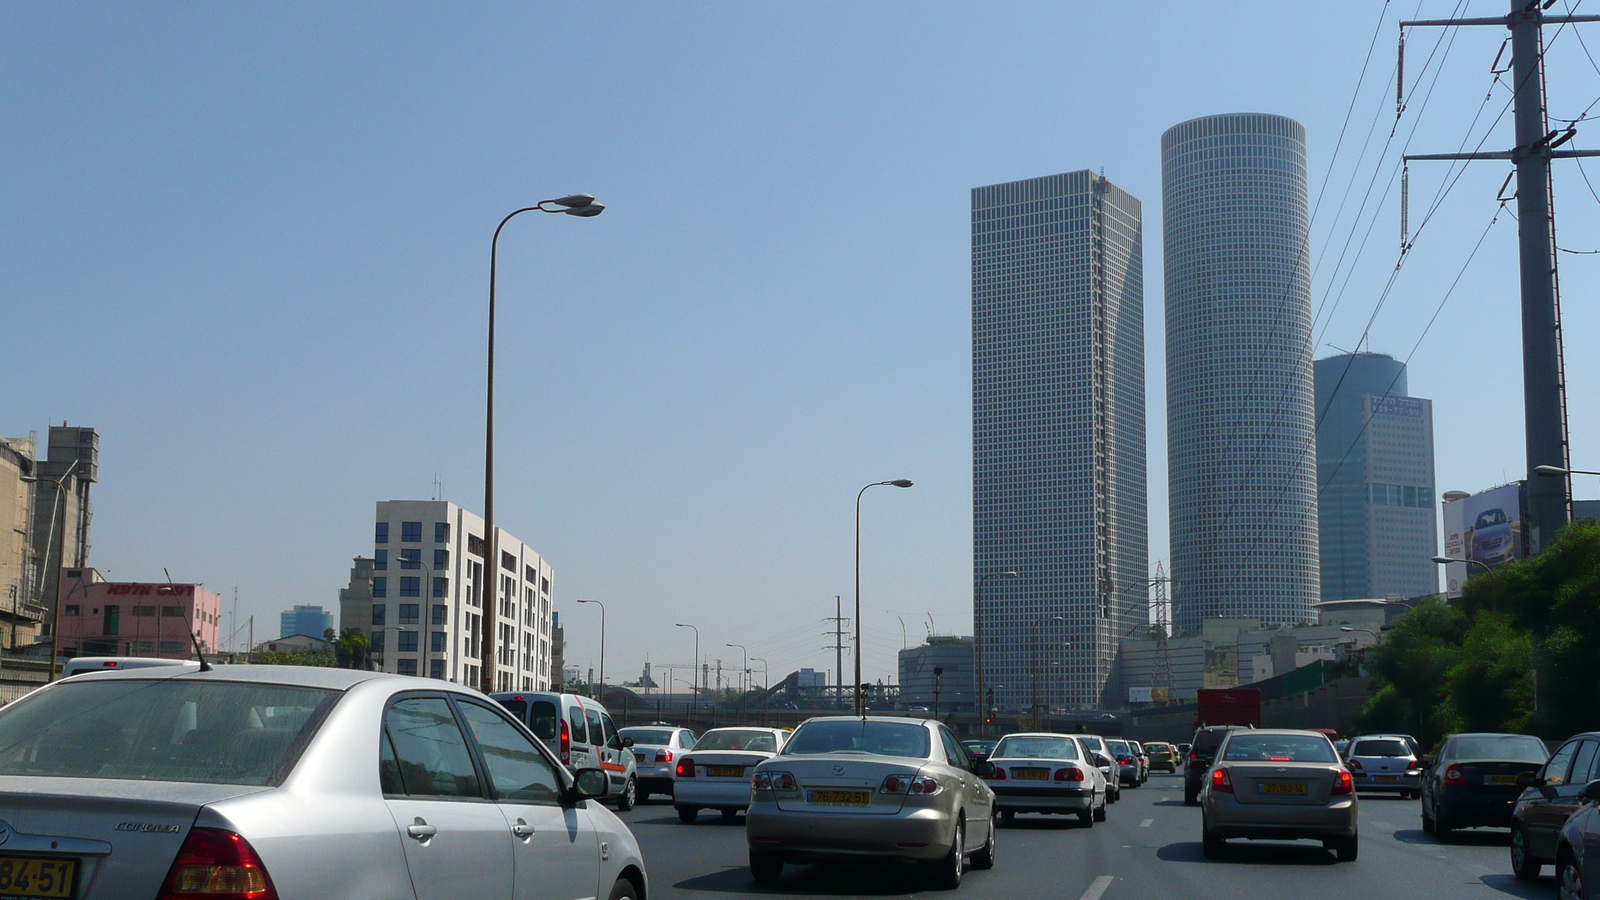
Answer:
0, 777, 267, 900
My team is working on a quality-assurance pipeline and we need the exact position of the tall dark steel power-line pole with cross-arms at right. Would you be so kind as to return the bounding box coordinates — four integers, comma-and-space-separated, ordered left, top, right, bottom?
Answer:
1395, 0, 1600, 554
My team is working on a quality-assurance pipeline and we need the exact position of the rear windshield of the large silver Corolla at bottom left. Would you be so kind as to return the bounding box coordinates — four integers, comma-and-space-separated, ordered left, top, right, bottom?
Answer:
0, 677, 339, 785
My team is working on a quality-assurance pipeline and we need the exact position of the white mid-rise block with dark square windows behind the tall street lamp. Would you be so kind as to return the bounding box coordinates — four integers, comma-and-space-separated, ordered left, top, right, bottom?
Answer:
348, 500, 555, 690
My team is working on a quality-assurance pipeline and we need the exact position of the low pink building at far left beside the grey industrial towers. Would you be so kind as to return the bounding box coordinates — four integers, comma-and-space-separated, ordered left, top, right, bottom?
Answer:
56, 567, 222, 660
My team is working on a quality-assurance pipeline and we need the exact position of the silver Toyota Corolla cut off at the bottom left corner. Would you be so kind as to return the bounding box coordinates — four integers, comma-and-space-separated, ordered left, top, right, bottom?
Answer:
0, 666, 646, 900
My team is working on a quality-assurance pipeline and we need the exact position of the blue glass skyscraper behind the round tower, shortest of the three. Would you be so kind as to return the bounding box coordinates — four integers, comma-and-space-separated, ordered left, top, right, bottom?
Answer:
1314, 352, 1438, 601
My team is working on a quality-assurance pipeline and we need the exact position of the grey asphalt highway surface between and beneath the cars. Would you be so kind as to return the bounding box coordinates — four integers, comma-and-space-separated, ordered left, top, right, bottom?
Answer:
622, 773, 1555, 900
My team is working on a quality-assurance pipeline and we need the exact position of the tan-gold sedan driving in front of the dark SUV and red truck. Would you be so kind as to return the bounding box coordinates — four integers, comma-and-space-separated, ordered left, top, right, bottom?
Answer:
1200, 729, 1358, 862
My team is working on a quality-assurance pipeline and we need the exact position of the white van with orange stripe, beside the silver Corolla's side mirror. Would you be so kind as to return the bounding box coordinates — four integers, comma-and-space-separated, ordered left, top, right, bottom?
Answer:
490, 690, 638, 810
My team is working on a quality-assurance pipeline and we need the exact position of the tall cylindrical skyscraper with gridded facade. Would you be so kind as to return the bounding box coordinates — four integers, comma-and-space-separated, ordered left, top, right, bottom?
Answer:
1162, 114, 1322, 631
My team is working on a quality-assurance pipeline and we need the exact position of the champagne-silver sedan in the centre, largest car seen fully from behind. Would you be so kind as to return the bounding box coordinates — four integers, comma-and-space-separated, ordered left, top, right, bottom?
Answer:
746, 716, 995, 887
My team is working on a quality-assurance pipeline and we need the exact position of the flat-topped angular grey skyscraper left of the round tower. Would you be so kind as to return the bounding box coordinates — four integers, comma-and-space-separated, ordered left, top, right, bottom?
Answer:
973, 170, 1149, 709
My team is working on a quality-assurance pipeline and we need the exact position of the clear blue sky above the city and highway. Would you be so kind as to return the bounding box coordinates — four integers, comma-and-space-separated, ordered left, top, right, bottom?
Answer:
0, 0, 1600, 681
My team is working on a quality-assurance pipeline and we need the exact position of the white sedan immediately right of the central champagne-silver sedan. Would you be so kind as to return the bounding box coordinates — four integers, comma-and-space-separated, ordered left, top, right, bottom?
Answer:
986, 732, 1107, 828
